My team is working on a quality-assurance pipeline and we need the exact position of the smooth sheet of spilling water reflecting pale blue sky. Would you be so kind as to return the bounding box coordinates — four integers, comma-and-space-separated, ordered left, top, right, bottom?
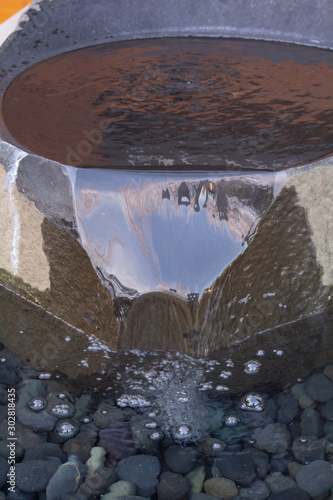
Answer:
75, 170, 277, 300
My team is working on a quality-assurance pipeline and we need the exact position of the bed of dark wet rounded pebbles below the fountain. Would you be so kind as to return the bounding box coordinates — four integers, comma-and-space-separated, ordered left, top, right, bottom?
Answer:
0, 348, 333, 500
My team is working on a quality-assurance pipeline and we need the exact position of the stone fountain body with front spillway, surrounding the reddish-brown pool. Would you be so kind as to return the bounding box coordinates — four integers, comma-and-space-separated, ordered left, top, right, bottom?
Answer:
0, 0, 333, 398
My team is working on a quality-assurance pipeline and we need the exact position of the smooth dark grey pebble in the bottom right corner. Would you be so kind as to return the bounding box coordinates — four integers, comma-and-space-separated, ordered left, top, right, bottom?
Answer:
296, 460, 333, 498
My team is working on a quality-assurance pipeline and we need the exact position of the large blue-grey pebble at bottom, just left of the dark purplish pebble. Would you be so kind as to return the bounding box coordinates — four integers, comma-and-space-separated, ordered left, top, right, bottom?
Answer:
115, 455, 161, 497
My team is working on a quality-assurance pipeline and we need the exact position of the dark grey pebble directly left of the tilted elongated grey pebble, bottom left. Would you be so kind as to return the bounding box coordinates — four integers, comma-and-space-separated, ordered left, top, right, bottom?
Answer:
16, 457, 61, 493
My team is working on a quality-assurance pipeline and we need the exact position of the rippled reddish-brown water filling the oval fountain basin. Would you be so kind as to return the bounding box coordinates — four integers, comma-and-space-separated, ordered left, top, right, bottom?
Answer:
2, 38, 333, 170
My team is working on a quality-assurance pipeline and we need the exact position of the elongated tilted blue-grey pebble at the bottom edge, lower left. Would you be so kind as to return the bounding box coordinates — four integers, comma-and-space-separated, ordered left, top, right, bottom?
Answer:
46, 456, 87, 500
